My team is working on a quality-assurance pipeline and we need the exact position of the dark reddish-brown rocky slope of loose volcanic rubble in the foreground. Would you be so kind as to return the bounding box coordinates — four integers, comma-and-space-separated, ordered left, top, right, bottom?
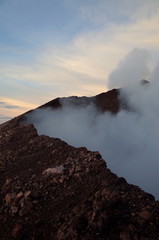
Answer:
0, 118, 159, 240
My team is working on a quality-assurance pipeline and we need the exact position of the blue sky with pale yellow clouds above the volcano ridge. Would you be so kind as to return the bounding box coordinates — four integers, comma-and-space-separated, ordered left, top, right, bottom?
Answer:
0, 0, 159, 123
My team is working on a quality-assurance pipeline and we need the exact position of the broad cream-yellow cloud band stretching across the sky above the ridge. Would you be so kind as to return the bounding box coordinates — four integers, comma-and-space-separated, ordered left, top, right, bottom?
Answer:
0, 7, 159, 91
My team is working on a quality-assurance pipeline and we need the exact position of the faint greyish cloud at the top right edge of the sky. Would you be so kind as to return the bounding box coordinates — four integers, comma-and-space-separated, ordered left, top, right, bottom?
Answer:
79, 0, 159, 26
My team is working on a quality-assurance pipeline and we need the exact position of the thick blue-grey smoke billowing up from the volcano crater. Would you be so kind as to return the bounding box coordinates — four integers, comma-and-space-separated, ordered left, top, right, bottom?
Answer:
28, 50, 159, 199
